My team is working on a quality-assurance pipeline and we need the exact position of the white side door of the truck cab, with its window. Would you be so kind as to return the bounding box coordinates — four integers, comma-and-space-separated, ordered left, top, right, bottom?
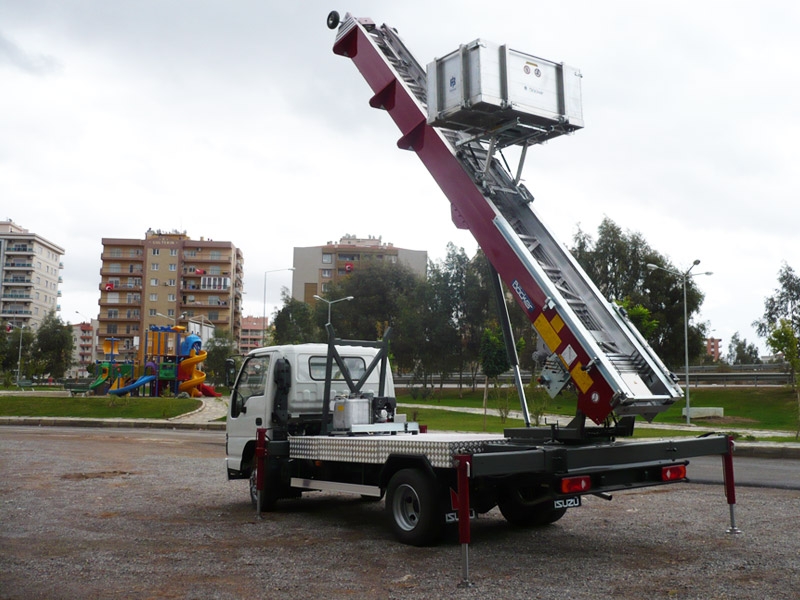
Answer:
226, 353, 274, 477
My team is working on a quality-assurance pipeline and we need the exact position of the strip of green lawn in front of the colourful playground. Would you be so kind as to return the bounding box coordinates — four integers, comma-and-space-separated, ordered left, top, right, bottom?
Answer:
0, 396, 202, 419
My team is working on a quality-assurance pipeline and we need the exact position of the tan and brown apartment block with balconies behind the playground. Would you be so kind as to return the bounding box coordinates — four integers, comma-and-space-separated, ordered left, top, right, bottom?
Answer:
97, 229, 244, 358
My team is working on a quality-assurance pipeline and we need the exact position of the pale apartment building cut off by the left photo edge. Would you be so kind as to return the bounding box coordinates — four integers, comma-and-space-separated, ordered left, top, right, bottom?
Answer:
0, 219, 64, 327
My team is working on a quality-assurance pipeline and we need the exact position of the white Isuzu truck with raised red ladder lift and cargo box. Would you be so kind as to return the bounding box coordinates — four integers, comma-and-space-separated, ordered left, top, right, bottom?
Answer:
226, 11, 738, 546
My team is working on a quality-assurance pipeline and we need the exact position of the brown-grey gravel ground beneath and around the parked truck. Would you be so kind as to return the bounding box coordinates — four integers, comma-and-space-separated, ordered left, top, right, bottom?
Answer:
0, 427, 800, 600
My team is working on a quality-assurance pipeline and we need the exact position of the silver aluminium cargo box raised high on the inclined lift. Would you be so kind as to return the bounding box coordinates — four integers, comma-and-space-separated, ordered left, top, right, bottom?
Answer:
427, 40, 583, 137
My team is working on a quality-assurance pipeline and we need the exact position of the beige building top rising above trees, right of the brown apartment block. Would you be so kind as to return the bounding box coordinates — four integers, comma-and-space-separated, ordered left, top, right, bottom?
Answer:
292, 235, 428, 302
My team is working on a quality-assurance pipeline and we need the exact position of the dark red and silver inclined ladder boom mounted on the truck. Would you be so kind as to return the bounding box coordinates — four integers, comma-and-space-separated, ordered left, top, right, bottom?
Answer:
333, 14, 682, 424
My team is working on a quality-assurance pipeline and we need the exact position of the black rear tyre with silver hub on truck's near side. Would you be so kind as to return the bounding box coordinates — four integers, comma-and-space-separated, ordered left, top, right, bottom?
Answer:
386, 469, 445, 546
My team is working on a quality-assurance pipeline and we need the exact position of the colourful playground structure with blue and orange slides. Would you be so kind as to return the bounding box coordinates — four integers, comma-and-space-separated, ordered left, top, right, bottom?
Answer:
89, 325, 221, 397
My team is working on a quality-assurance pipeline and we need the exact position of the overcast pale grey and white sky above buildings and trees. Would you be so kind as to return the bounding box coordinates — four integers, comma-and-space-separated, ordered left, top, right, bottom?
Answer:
0, 0, 800, 350
